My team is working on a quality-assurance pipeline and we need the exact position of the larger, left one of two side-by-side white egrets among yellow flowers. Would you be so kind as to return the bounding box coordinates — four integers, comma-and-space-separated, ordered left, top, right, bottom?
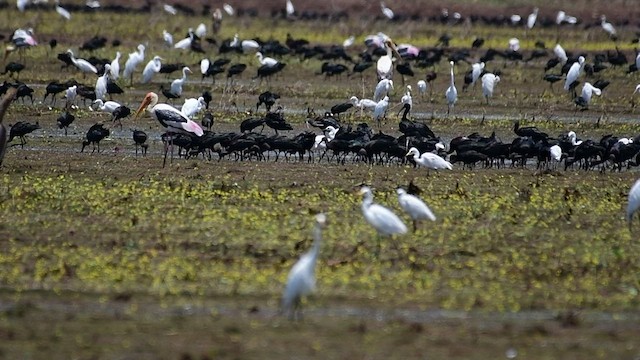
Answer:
360, 186, 407, 254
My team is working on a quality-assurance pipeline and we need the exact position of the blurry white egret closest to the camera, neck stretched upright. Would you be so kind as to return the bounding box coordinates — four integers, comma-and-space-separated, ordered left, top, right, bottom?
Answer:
282, 214, 327, 318
